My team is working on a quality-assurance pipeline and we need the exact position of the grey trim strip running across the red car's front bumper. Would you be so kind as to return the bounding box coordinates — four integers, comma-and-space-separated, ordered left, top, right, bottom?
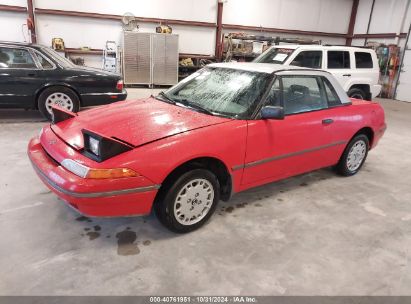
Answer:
30, 159, 161, 198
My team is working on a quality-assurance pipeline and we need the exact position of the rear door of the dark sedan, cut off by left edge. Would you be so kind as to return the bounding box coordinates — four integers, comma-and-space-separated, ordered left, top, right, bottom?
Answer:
0, 46, 39, 108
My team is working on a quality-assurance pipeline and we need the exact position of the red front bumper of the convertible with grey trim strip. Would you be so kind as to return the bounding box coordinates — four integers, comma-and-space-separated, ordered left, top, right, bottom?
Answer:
28, 138, 160, 216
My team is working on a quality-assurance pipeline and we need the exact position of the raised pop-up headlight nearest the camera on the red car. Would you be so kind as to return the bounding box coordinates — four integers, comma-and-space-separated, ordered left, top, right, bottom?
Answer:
82, 129, 134, 162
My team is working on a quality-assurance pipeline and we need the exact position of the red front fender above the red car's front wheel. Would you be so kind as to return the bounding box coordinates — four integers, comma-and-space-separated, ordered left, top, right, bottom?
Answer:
125, 120, 247, 190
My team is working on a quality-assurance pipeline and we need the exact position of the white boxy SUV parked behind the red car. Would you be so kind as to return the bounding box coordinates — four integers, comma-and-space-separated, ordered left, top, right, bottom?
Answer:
254, 45, 381, 100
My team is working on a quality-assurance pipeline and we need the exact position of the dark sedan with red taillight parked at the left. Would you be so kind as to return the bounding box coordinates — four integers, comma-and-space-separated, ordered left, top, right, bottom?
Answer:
0, 42, 127, 119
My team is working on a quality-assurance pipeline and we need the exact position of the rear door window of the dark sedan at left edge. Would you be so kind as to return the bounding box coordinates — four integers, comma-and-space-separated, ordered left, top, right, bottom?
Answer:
0, 47, 37, 69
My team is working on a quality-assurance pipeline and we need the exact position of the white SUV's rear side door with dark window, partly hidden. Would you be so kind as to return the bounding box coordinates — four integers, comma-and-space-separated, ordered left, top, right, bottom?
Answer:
326, 50, 353, 91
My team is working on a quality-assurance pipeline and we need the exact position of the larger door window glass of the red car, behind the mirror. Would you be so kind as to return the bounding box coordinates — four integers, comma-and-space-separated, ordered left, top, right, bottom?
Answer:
281, 76, 327, 115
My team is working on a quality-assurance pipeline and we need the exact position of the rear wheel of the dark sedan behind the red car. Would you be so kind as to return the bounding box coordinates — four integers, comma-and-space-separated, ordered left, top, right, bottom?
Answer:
37, 86, 80, 120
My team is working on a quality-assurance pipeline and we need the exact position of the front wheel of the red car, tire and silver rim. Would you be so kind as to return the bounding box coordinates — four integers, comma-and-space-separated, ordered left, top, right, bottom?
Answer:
154, 169, 220, 233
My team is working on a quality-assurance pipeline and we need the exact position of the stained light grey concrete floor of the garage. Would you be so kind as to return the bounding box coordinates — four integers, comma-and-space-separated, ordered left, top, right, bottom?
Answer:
0, 89, 411, 295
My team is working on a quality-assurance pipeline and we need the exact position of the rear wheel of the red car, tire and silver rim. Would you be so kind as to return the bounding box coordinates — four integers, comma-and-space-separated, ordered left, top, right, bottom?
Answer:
336, 134, 370, 176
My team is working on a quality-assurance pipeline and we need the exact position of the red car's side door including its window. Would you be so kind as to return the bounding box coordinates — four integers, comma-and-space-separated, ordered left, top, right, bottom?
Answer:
242, 71, 335, 188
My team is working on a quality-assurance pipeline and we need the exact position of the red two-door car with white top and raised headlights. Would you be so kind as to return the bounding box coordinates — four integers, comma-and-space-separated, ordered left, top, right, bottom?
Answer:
28, 63, 386, 232
